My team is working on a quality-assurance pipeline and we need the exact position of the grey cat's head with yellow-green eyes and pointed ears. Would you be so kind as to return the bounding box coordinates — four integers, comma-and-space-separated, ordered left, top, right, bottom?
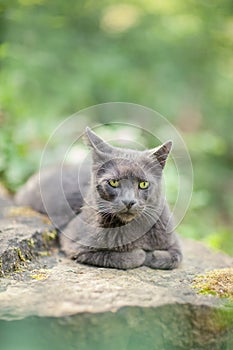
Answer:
86, 128, 172, 224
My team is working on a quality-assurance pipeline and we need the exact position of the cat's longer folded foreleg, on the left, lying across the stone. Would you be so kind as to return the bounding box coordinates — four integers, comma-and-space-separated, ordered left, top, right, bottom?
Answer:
73, 249, 146, 270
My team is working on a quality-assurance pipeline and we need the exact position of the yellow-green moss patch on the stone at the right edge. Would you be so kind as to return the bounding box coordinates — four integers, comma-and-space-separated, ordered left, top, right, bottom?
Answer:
193, 268, 233, 301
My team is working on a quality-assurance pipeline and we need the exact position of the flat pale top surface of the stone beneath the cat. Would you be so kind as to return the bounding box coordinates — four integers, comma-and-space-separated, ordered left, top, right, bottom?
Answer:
0, 240, 233, 318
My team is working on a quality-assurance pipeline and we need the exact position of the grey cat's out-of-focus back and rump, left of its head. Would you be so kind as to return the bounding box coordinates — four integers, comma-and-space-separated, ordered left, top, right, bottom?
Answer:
15, 163, 91, 227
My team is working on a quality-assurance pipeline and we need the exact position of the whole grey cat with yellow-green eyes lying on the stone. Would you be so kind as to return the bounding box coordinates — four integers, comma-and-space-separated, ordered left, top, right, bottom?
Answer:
16, 128, 182, 269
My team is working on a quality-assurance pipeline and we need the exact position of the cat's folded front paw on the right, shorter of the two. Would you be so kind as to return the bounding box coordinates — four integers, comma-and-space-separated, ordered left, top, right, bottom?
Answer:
144, 249, 182, 270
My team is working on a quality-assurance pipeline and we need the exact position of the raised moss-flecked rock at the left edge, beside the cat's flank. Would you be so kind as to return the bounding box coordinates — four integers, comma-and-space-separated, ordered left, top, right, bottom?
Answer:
0, 192, 57, 277
